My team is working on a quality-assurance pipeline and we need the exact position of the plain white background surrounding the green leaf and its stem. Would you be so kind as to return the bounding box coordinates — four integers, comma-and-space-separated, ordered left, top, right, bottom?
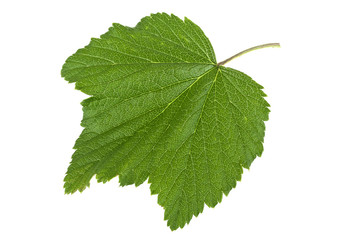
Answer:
0, 0, 341, 240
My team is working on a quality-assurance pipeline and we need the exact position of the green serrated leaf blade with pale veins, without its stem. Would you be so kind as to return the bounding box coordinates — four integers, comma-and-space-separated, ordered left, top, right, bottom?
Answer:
61, 13, 269, 230
